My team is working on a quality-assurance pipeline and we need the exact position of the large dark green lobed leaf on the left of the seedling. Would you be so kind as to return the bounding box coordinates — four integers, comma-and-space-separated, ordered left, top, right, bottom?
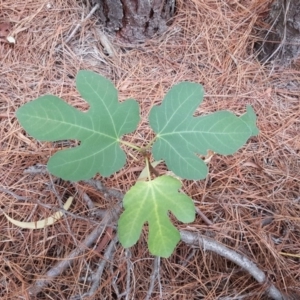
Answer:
17, 71, 139, 181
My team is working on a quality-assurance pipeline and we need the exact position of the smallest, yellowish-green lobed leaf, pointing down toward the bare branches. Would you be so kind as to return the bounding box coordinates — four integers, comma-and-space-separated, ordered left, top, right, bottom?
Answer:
118, 176, 195, 258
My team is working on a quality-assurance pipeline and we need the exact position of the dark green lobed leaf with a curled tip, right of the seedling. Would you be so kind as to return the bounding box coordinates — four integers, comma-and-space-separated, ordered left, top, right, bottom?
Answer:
149, 82, 258, 180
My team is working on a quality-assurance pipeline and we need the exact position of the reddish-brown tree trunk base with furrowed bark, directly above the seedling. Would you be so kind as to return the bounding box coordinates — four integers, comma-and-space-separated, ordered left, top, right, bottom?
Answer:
93, 0, 175, 42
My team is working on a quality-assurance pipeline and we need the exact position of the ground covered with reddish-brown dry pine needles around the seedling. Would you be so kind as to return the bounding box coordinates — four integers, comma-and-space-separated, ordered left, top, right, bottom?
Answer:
0, 0, 300, 299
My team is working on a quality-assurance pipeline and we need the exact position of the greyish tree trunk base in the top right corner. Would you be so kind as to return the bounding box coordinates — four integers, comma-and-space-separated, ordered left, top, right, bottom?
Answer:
259, 0, 300, 65
